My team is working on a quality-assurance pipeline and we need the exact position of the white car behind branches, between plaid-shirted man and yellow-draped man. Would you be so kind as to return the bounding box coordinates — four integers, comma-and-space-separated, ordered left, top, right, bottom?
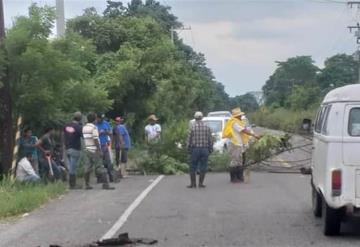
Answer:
190, 117, 230, 153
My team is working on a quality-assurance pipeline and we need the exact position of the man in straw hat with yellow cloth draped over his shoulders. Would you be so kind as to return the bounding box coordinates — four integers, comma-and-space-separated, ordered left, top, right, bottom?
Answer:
225, 107, 260, 183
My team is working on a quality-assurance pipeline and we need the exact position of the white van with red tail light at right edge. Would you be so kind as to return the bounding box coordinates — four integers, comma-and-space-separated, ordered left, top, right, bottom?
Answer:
311, 84, 360, 235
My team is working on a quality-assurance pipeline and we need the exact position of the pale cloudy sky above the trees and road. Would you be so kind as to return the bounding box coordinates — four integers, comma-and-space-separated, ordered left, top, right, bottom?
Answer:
3, 0, 360, 96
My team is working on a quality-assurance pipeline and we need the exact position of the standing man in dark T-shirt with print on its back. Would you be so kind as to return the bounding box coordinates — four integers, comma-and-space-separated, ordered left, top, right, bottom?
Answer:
64, 112, 82, 189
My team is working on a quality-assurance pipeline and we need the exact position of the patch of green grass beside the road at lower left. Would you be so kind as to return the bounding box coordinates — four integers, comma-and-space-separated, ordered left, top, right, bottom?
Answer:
0, 178, 66, 219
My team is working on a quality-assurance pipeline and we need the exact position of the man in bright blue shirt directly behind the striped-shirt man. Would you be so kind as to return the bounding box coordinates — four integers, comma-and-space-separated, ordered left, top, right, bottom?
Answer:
96, 114, 115, 182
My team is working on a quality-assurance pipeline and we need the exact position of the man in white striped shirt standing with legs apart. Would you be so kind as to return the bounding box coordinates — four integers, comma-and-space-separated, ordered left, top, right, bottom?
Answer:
82, 113, 114, 190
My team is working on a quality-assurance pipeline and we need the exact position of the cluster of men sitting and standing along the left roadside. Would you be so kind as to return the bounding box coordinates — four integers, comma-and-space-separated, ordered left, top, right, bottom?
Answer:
16, 112, 136, 189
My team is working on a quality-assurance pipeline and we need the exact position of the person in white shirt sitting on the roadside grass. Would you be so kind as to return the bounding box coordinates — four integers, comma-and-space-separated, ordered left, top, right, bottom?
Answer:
16, 153, 40, 182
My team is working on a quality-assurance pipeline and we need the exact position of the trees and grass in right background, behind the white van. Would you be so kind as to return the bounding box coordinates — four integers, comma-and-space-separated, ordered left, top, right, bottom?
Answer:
250, 54, 359, 133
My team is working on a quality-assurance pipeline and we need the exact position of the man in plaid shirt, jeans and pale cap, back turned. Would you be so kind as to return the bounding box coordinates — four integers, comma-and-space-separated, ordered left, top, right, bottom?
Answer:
187, 112, 213, 188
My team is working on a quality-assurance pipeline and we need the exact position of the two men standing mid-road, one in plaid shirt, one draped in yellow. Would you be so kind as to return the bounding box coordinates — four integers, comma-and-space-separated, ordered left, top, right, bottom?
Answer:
187, 107, 260, 188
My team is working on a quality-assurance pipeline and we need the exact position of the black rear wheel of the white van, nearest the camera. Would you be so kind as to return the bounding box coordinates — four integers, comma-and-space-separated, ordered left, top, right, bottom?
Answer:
322, 201, 343, 236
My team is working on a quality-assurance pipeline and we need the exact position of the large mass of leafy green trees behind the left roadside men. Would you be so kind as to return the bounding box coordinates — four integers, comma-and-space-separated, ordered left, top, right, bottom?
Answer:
0, 0, 258, 173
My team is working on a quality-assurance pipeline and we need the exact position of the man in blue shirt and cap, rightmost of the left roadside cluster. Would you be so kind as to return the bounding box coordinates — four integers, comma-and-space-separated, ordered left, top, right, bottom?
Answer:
113, 117, 131, 177
